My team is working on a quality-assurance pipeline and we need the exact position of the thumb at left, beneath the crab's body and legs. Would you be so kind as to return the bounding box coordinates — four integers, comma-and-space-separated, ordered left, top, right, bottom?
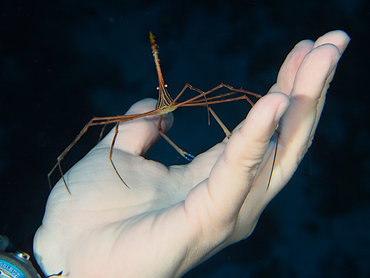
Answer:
96, 98, 173, 155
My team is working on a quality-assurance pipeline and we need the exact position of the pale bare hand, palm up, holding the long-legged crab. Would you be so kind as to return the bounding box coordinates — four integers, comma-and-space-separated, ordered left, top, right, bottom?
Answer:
34, 31, 350, 278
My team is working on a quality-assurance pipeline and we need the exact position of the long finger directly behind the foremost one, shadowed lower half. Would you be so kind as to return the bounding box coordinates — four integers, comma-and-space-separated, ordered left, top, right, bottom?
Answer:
274, 44, 340, 186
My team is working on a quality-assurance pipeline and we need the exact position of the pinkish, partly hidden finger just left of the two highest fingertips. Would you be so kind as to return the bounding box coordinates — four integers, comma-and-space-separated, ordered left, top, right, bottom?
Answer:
269, 40, 313, 95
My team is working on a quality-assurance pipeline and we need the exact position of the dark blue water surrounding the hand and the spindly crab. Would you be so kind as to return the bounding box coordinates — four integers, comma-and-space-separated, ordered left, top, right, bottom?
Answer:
0, 0, 370, 278
